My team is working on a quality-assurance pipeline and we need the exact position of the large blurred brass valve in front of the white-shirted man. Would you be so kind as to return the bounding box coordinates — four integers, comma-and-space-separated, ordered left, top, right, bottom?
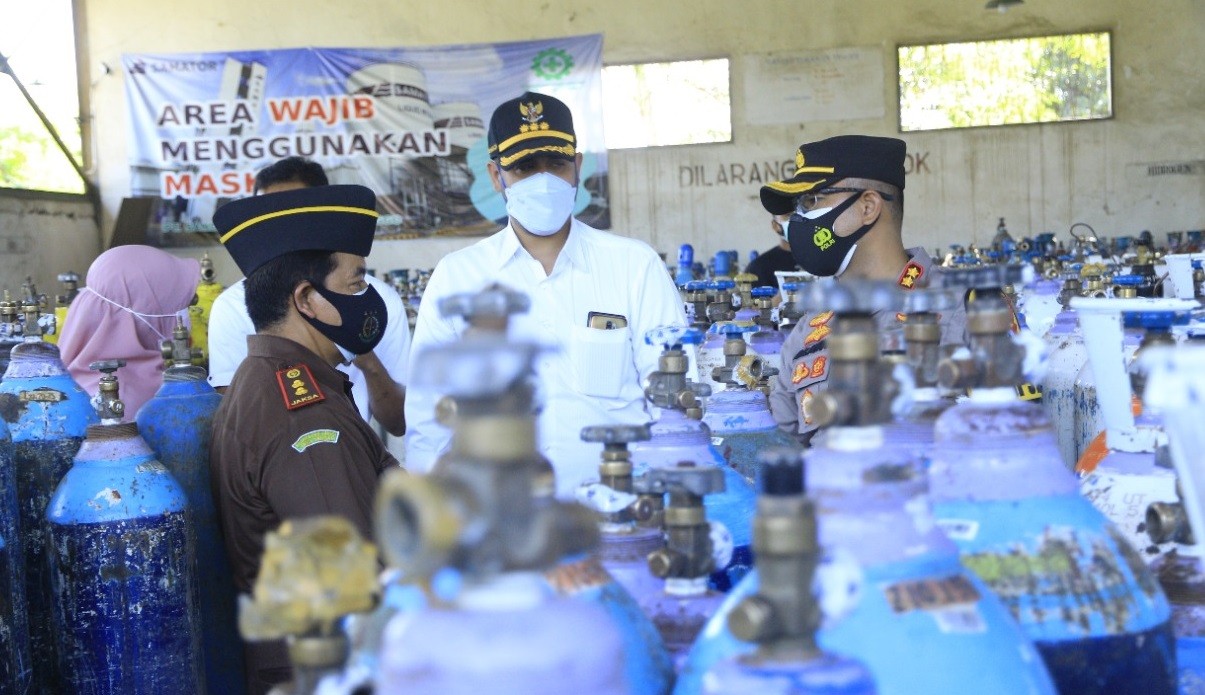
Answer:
376, 336, 599, 579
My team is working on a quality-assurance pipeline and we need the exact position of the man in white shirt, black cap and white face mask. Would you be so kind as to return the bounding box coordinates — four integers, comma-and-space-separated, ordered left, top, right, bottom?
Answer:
405, 92, 686, 497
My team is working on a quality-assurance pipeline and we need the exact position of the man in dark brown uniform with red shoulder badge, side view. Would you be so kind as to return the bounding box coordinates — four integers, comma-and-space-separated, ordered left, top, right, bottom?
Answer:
210, 185, 398, 694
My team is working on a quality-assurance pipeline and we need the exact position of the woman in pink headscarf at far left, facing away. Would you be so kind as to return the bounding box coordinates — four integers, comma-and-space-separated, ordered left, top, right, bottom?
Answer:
59, 245, 201, 422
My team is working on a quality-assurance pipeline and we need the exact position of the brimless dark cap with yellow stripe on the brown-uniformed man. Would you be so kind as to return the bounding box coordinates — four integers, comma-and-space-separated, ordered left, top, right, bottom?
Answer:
213, 185, 377, 276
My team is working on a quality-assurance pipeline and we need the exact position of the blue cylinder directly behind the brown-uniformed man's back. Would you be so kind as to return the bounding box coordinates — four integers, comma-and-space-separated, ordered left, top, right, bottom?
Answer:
135, 323, 246, 695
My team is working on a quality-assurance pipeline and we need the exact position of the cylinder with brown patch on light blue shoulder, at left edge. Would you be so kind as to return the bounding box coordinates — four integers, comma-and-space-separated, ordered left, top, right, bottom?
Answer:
0, 299, 98, 694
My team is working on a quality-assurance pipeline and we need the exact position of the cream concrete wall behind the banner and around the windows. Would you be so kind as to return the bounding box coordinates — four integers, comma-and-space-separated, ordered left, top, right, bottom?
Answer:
78, 0, 1205, 282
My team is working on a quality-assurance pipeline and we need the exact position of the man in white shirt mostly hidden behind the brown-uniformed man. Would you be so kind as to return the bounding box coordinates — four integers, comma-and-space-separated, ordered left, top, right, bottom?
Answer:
210, 157, 410, 437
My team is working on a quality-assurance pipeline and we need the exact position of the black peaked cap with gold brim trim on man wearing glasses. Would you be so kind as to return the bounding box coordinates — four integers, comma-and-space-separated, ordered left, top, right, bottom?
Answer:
762, 135, 907, 214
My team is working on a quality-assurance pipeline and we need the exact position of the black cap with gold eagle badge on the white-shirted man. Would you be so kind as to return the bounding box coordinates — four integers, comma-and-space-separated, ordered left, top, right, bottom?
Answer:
487, 92, 577, 171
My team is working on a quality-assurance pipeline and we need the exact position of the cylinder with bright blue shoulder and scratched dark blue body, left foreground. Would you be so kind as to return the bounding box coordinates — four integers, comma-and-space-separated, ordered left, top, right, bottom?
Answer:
46, 360, 205, 695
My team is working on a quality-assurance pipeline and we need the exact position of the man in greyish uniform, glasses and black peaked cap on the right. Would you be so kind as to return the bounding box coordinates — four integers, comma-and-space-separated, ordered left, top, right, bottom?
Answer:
762, 135, 966, 442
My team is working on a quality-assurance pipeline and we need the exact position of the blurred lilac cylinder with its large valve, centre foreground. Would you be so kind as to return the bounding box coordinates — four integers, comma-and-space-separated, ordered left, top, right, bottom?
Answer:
375, 336, 631, 695
